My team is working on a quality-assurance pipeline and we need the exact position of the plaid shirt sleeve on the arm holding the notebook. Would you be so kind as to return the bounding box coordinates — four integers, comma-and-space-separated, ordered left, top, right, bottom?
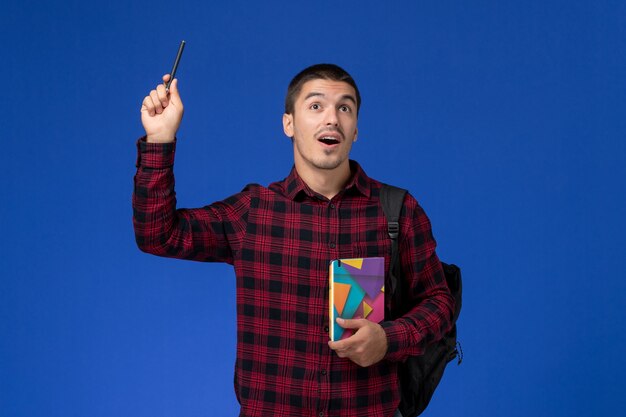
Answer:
381, 194, 454, 361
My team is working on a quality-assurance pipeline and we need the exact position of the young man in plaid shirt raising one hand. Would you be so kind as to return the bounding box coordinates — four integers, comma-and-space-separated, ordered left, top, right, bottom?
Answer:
133, 64, 454, 417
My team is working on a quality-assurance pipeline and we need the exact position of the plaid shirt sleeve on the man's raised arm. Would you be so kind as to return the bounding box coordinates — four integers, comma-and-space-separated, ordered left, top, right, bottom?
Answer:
132, 138, 250, 264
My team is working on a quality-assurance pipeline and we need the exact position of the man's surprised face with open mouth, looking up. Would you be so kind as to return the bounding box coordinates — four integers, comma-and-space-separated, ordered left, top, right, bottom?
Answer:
283, 79, 357, 170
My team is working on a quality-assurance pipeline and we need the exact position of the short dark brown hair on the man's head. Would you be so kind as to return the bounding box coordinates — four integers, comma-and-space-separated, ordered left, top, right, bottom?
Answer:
285, 64, 361, 115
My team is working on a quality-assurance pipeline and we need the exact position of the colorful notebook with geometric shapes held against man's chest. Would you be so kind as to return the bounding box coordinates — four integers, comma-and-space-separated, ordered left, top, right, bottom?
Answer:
329, 258, 385, 340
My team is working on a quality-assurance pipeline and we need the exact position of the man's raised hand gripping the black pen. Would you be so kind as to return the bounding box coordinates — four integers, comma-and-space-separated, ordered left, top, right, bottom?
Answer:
141, 74, 183, 143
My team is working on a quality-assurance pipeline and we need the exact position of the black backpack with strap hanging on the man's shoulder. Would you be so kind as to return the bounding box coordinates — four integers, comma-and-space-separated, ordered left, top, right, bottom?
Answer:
380, 184, 463, 417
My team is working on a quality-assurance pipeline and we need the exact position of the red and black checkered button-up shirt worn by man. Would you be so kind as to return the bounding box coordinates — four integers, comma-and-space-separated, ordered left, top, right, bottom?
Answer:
133, 140, 454, 417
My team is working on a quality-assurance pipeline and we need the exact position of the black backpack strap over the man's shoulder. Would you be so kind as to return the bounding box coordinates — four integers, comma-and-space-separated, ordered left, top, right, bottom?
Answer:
380, 184, 407, 308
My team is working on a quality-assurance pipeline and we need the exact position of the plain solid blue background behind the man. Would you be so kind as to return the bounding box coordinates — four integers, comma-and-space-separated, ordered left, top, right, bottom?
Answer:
0, 0, 626, 417
